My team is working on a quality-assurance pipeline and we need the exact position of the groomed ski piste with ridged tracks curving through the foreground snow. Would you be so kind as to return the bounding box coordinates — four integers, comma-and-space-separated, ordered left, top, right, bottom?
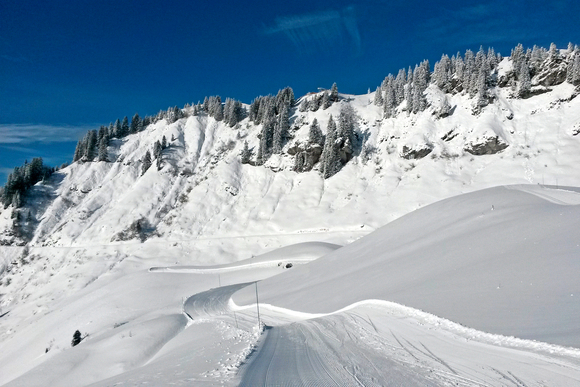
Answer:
174, 283, 580, 386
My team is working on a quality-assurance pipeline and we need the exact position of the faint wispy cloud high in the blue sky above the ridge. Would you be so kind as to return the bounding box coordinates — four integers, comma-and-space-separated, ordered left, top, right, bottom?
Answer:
265, 6, 361, 53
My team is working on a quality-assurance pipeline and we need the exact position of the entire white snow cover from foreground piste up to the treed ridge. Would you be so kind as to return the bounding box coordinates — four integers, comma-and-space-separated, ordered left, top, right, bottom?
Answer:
0, 72, 580, 386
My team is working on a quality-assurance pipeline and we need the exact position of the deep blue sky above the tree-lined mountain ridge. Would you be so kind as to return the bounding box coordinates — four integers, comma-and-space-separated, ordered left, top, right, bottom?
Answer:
0, 0, 580, 184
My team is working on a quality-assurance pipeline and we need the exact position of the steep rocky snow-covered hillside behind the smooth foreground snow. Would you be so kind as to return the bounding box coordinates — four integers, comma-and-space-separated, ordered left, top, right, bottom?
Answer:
0, 46, 580, 336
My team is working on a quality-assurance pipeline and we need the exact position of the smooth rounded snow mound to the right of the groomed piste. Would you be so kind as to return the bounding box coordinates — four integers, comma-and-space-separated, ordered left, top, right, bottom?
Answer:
234, 185, 580, 347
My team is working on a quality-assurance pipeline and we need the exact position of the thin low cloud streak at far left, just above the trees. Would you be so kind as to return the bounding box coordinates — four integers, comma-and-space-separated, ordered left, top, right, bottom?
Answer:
0, 124, 97, 144
